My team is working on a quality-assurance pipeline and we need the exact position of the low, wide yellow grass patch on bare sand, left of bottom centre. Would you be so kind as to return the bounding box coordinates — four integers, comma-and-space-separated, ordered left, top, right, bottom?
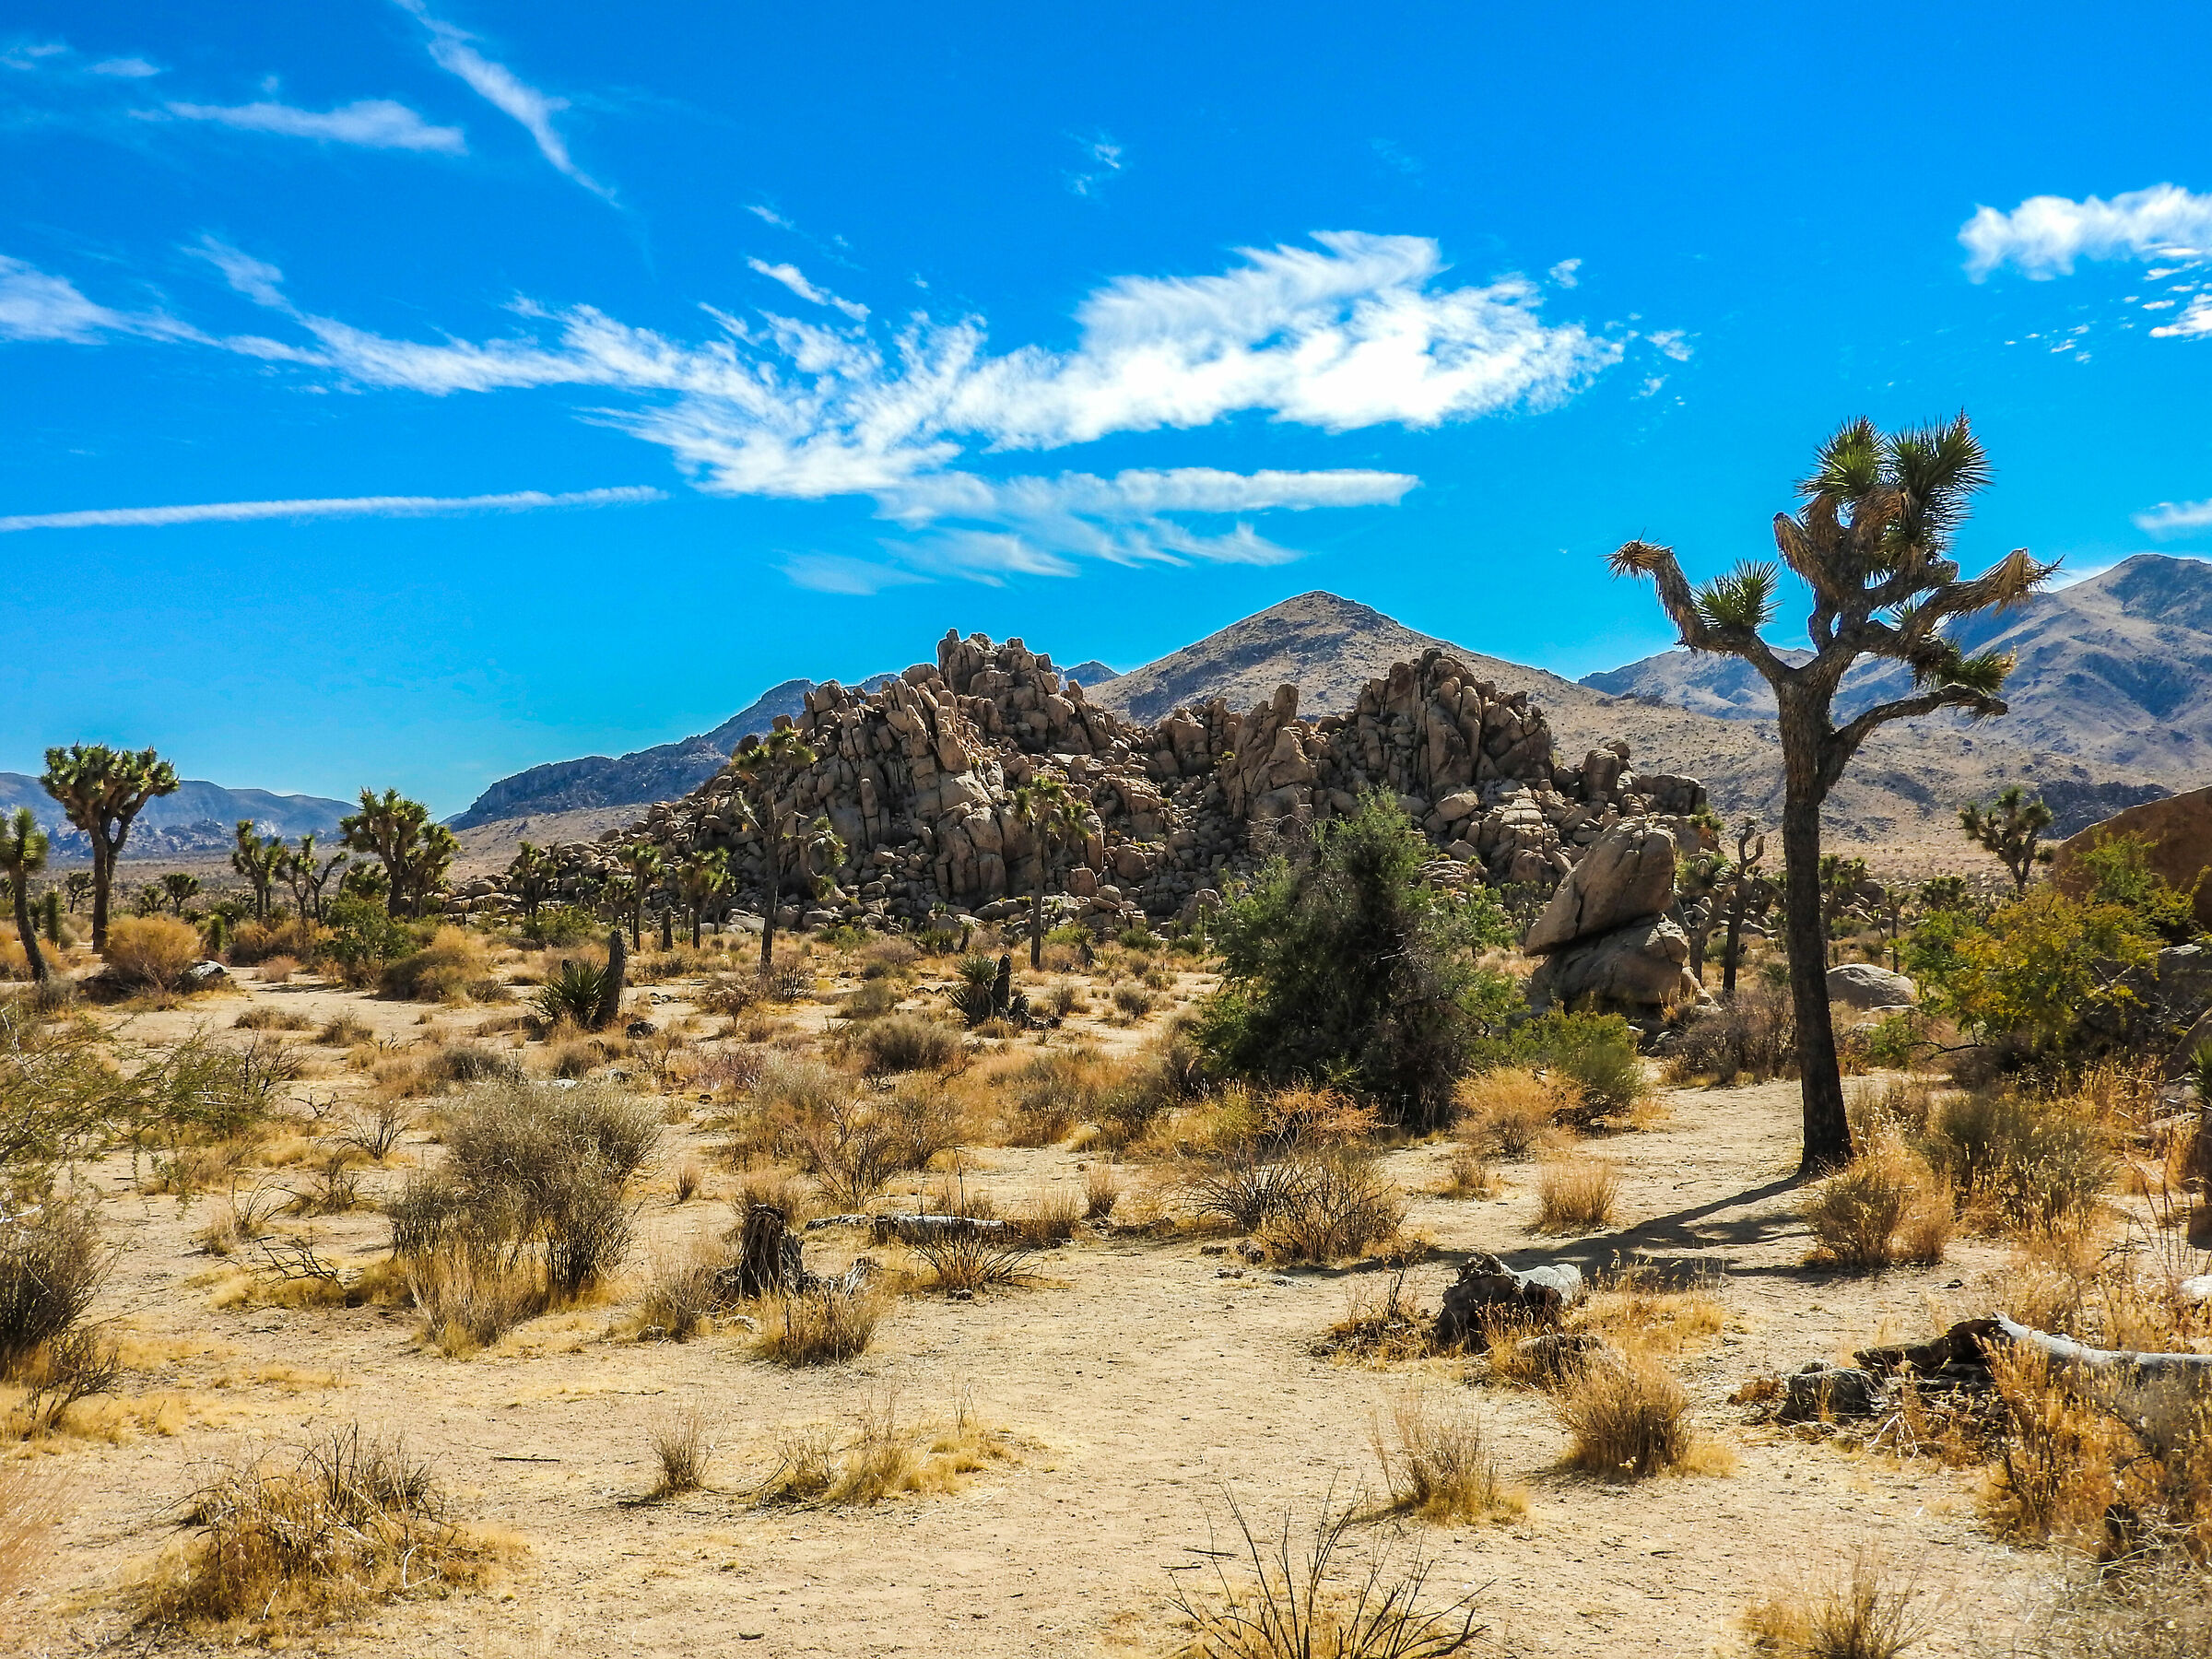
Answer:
752, 1395, 1019, 1509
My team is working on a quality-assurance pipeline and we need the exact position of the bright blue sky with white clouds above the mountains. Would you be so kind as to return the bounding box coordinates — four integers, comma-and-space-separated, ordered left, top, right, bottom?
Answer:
0, 0, 2212, 812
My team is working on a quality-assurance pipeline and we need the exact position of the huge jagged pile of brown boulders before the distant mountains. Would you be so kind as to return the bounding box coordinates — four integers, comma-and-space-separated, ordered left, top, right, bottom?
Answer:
453, 632, 1705, 927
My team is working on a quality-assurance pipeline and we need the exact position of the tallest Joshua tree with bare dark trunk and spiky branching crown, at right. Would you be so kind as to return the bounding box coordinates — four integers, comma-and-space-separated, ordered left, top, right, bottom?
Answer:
1613, 416, 2057, 1174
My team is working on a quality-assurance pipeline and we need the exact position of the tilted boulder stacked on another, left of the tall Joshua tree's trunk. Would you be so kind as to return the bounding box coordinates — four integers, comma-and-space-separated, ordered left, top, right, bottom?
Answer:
1522, 818, 1703, 1019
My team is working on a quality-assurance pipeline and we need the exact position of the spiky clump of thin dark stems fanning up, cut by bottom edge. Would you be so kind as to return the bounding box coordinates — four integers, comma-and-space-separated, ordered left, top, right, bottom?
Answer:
1172, 1493, 1488, 1659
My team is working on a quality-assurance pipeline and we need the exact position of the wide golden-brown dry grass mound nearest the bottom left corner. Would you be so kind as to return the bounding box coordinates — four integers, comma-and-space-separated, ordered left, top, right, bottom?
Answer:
139, 1425, 493, 1630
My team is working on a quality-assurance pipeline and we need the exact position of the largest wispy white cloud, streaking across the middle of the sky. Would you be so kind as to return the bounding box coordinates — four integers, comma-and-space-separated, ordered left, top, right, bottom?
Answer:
0, 232, 1628, 582
